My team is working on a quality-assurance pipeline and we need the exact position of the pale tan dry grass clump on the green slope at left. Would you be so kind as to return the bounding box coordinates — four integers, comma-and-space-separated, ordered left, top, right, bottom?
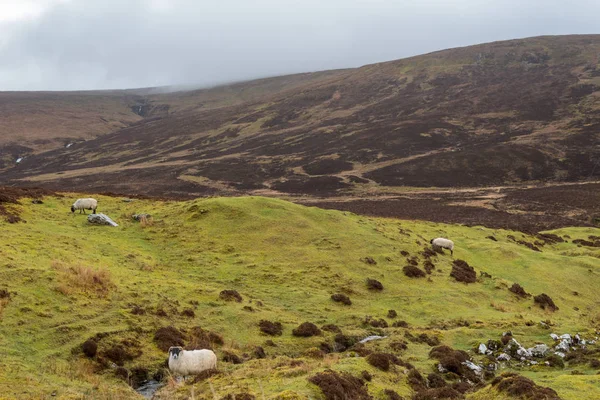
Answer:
52, 261, 116, 296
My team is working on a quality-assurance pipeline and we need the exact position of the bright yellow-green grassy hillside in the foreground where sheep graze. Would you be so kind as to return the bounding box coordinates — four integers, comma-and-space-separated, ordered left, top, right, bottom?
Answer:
0, 194, 600, 400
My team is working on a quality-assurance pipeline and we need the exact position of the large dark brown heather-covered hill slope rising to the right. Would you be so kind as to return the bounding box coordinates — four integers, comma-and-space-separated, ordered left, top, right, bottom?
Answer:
0, 35, 600, 196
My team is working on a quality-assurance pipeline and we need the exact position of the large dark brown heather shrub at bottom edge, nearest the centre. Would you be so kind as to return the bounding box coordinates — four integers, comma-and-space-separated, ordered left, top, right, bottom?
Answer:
308, 370, 372, 400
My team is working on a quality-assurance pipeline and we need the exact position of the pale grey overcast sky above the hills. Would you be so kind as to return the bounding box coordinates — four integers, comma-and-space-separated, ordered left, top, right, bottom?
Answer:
0, 0, 600, 90
